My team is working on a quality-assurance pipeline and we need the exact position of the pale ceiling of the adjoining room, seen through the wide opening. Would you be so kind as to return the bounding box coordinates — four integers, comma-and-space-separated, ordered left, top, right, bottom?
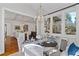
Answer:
5, 10, 34, 23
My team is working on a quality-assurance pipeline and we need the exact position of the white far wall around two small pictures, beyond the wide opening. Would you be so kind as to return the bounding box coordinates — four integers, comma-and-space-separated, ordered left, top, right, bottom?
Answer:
5, 20, 35, 36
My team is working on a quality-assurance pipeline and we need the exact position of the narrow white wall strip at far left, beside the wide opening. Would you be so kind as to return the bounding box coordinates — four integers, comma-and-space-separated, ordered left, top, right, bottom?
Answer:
0, 9, 4, 54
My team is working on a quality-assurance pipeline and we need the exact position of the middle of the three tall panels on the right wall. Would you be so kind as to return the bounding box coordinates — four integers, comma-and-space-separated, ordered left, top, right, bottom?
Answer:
52, 15, 61, 34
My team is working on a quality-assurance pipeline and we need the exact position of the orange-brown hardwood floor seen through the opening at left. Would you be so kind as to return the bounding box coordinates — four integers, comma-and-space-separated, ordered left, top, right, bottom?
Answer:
0, 36, 19, 56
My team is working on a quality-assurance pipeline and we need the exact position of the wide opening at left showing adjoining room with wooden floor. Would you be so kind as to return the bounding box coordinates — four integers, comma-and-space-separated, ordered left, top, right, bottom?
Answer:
2, 9, 35, 55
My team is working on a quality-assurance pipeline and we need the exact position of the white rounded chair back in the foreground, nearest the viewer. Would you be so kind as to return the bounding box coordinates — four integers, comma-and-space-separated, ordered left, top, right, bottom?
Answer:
22, 44, 43, 56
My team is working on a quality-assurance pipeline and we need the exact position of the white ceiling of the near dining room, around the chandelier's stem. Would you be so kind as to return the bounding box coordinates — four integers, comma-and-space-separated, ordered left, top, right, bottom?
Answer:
0, 3, 72, 17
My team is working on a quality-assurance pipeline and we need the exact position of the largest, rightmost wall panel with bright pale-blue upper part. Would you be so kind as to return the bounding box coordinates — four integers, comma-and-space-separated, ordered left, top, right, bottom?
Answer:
65, 12, 76, 35
